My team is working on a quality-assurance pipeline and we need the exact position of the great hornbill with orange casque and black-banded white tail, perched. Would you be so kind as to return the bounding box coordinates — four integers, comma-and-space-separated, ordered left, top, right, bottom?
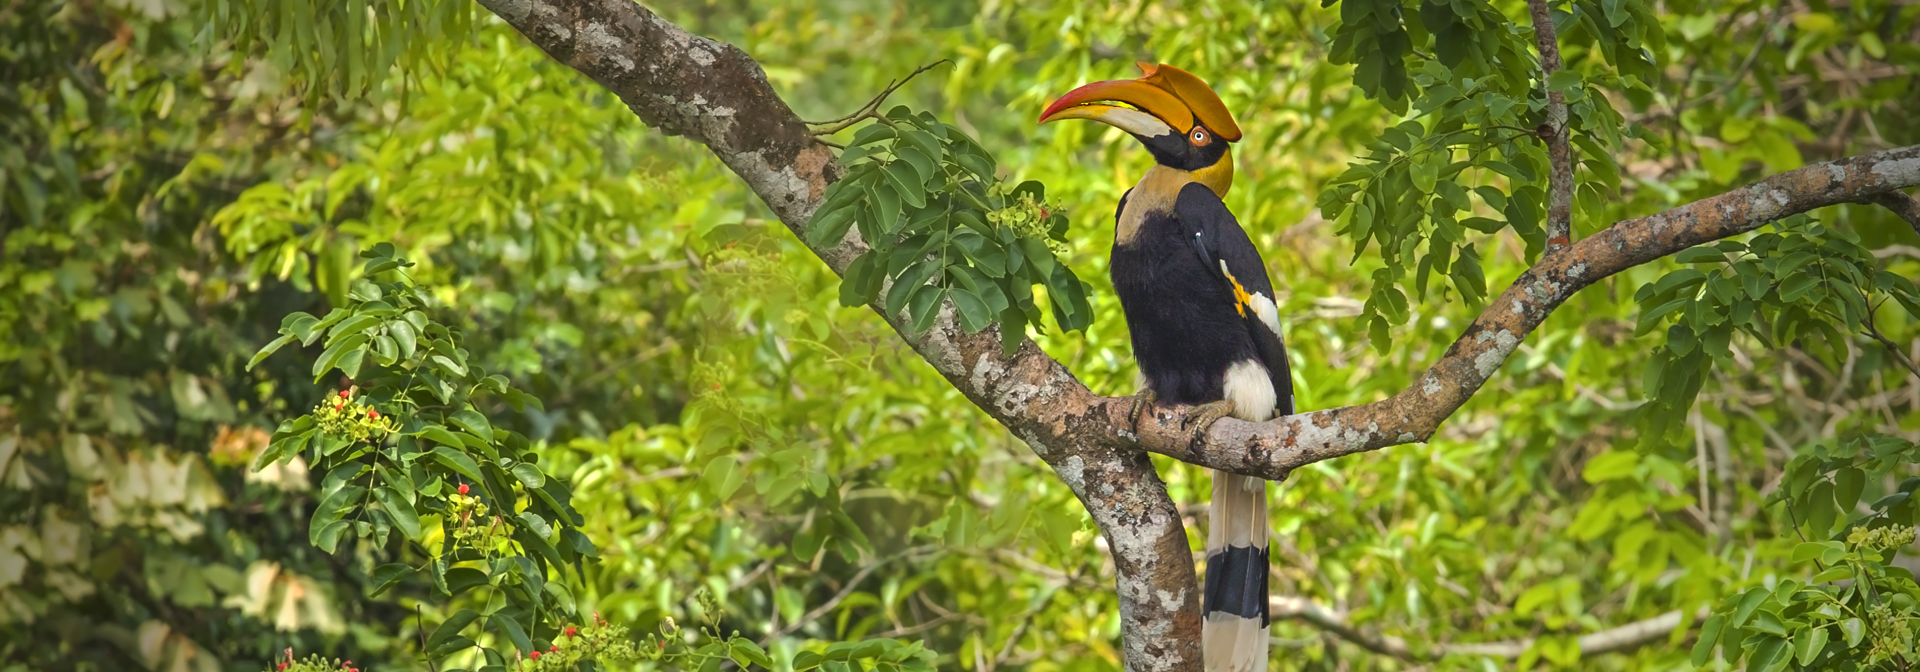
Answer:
1041, 63, 1294, 672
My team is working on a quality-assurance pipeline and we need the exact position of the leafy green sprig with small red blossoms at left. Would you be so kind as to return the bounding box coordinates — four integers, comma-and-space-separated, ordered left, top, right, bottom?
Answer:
253, 244, 599, 666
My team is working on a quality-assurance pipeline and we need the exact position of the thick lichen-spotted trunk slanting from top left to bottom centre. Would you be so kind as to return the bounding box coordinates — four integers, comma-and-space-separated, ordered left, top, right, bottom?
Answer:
478, 0, 1200, 672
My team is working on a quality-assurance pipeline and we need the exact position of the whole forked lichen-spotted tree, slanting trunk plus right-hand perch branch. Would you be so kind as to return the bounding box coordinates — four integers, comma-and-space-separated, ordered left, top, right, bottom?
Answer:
464, 0, 1920, 672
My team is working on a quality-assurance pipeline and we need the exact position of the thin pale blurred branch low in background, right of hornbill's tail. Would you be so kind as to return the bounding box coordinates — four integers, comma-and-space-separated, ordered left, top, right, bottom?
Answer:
1267, 597, 1707, 662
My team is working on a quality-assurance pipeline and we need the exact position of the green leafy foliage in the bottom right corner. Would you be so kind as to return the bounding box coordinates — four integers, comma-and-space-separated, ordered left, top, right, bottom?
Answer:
1692, 436, 1920, 672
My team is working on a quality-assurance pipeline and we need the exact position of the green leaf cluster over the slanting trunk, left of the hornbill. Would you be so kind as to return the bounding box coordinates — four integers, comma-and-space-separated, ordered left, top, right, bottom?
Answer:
806, 106, 1092, 353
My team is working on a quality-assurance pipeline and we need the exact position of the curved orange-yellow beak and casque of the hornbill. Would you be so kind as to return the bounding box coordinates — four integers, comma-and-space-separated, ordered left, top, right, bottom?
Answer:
1039, 63, 1240, 140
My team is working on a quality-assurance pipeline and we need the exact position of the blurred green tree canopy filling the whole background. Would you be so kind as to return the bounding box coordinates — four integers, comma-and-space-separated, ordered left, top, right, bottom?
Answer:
0, 0, 1920, 672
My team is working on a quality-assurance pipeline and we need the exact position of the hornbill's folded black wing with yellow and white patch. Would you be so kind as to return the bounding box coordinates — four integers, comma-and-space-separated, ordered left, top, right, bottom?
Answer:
1173, 182, 1294, 415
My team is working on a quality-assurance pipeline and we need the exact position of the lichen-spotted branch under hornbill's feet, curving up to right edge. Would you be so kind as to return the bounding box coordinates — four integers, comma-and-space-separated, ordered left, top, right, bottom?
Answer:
1108, 146, 1920, 480
